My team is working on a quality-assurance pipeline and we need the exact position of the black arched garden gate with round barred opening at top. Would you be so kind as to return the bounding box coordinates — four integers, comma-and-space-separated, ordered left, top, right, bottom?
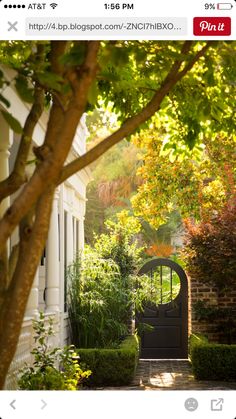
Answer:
136, 258, 188, 359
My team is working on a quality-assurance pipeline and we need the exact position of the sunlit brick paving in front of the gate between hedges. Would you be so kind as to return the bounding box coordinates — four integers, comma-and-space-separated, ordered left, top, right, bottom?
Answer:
98, 359, 236, 390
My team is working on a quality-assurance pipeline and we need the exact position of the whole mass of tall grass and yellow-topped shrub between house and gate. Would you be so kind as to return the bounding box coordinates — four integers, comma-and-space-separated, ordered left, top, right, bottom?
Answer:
67, 214, 151, 348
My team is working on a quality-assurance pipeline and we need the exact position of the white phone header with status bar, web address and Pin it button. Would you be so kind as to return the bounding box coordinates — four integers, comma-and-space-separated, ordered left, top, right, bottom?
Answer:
0, 0, 235, 40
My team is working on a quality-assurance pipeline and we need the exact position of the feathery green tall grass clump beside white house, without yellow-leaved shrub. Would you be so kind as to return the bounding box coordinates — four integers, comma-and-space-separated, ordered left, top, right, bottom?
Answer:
68, 249, 131, 348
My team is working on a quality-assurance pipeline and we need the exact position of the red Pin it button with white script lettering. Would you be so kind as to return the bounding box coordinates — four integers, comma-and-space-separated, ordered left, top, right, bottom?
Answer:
193, 17, 231, 36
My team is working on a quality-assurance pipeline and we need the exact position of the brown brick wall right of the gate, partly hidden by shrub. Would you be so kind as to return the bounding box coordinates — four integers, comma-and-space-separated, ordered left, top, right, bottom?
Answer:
189, 278, 236, 342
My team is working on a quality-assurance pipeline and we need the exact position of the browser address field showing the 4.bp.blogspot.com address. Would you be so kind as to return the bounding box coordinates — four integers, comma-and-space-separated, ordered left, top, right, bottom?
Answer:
26, 17, 187, 38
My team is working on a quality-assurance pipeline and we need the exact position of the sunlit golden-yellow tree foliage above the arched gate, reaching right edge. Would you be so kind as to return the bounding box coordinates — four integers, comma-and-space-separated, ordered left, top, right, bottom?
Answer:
132, 131, 236, 227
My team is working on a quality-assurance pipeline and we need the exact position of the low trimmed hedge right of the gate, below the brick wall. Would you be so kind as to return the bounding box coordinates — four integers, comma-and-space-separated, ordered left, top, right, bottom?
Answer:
190, 335, 236, 381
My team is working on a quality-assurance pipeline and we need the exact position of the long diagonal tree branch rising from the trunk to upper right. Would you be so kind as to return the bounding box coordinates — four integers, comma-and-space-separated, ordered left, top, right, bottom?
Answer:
58, 41, 211, 184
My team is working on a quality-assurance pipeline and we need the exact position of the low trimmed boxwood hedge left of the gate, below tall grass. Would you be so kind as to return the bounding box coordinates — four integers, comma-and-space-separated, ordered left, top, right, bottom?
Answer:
78, 335, 139, 387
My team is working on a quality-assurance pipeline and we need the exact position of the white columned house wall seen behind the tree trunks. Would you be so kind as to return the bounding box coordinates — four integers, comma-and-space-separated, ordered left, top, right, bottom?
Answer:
0, 73, 91, 389
